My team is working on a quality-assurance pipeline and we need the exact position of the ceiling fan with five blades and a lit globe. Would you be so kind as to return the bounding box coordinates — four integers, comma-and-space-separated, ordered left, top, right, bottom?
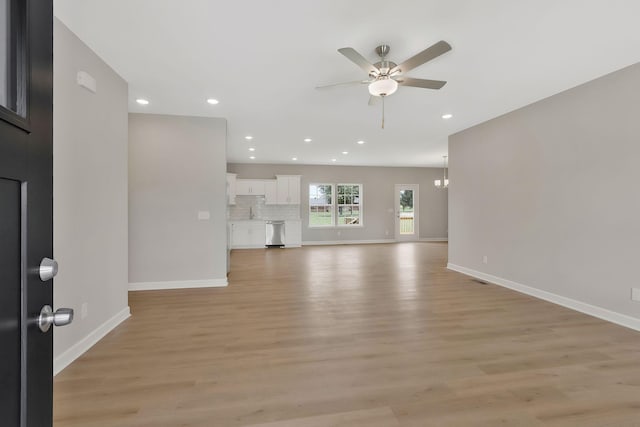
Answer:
316, 40, 451, 129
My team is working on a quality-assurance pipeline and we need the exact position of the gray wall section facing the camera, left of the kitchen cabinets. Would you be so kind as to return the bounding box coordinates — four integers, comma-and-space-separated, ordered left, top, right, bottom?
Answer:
129, 114, 227, 283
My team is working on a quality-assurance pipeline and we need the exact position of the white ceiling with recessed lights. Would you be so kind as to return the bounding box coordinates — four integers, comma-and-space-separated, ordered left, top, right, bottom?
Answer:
54, 0, 640, 166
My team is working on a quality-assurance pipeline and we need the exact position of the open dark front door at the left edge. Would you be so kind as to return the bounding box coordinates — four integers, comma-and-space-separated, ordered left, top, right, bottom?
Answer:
0, 0, 58, 427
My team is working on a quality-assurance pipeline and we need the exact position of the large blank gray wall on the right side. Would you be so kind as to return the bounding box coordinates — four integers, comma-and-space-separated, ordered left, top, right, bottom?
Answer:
449, 60, 640, 318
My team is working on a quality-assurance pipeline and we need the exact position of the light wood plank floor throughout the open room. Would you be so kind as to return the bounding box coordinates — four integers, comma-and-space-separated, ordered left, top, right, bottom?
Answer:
54, 243, 640, 427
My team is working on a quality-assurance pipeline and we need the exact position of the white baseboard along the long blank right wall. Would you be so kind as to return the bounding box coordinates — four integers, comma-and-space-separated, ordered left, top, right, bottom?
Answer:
447, 263, 640, 331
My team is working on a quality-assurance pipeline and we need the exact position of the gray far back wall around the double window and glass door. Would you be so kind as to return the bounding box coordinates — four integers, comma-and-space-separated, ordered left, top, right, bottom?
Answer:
227, 164, 447, 242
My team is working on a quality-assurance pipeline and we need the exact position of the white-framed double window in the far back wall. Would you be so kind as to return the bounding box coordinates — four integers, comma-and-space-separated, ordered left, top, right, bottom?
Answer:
309, 184, 362, 227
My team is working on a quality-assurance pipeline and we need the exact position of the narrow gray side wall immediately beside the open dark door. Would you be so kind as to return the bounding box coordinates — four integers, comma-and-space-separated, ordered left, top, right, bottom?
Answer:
53, 19, 128, 364
